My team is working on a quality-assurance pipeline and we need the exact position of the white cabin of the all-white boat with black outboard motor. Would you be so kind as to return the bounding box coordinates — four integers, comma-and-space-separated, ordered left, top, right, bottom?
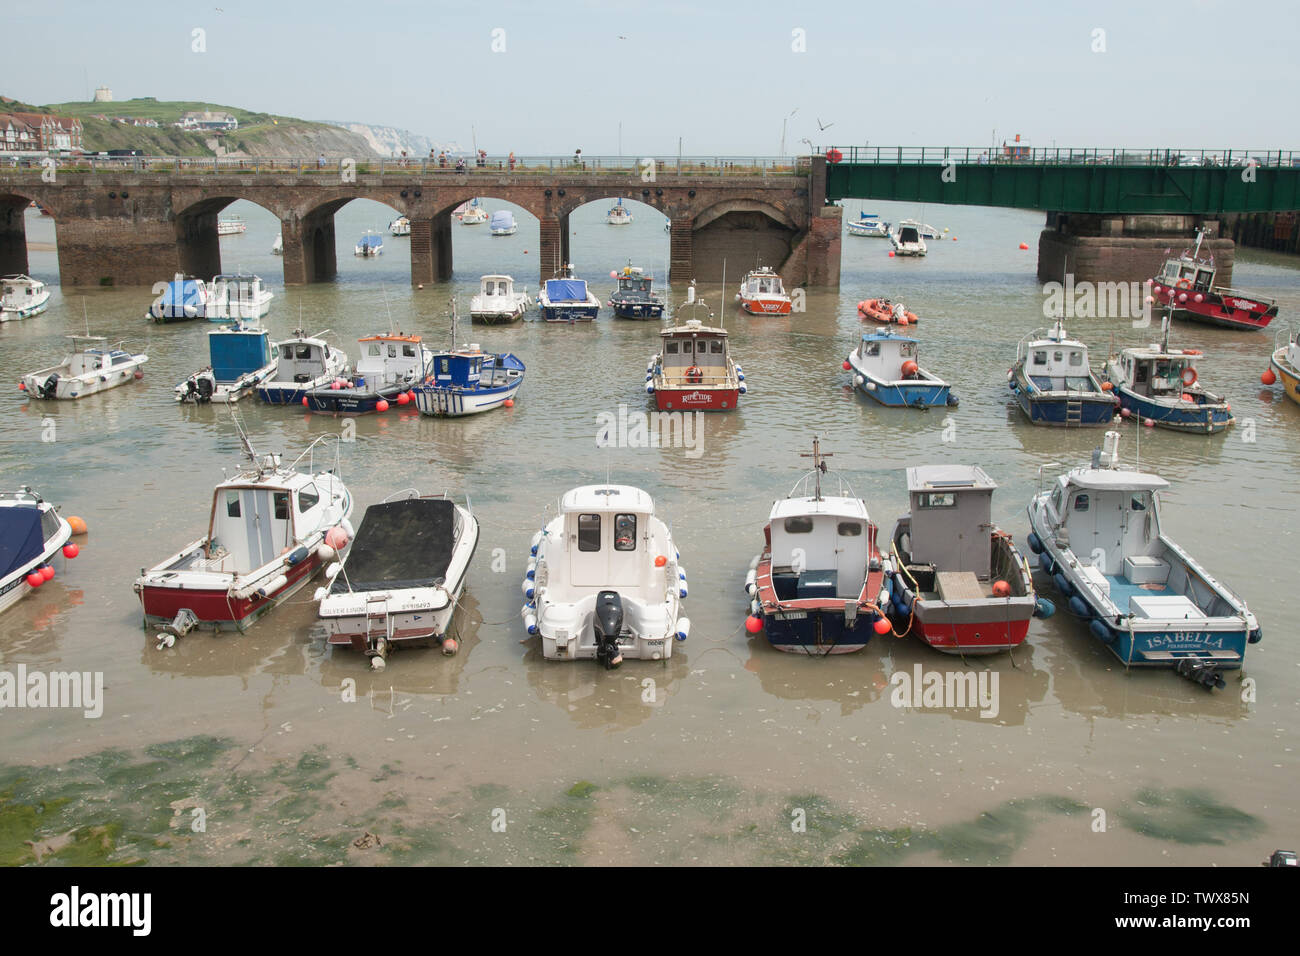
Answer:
560, 485, 667, 589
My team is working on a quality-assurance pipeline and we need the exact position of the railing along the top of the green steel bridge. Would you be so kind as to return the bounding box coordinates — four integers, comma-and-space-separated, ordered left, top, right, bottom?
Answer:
818, 143, 1300, 168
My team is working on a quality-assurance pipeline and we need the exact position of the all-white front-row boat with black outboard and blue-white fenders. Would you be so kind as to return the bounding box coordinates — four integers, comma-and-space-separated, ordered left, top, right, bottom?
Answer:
523, 485, 690, 669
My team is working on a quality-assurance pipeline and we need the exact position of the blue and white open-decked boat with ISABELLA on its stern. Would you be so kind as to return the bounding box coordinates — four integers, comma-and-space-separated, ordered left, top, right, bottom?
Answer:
1028, 432, 1262, 687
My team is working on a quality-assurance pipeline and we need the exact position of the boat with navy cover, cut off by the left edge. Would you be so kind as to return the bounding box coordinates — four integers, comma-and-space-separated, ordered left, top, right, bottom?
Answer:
0, 485, 78, 611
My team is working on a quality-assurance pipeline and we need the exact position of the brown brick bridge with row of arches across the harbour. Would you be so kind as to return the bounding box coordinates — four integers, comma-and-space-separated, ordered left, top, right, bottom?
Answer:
0, 159, 841, 287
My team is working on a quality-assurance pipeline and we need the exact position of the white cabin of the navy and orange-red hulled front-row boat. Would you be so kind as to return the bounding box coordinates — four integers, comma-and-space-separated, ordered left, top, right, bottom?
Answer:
768, 496, 871, 601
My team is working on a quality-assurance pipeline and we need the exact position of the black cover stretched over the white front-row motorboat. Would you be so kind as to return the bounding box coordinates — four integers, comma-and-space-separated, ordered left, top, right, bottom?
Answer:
330, 498, 456, 594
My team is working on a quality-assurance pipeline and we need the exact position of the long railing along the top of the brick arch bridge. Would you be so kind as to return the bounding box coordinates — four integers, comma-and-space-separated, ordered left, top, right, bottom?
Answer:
0, 153, 811, 182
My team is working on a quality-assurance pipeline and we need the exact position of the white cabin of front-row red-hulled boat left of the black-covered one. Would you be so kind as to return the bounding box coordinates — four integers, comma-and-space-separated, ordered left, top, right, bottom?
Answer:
203, 468, 332, 574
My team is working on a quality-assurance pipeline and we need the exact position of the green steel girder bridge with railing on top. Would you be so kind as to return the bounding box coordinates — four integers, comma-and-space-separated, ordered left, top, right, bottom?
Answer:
820, 144, 1300, 216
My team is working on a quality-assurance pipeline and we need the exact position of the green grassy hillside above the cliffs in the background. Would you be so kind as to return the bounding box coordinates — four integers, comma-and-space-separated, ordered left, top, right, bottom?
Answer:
0, 96, 374, 159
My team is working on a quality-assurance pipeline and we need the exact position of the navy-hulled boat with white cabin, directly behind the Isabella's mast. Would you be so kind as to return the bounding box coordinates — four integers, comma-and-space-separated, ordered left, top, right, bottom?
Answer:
1008, 319, 1117, 427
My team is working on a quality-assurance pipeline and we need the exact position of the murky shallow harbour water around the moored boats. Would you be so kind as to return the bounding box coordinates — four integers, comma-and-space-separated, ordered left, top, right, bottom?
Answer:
0, 199, 1300, 865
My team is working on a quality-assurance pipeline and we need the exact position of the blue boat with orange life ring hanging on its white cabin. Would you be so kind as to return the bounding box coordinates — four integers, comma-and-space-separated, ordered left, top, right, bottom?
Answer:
1102, 315, 1234, 434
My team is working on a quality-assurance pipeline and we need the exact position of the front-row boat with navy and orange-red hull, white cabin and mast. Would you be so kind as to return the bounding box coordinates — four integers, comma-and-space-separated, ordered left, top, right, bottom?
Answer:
745, 437, 889, 657
